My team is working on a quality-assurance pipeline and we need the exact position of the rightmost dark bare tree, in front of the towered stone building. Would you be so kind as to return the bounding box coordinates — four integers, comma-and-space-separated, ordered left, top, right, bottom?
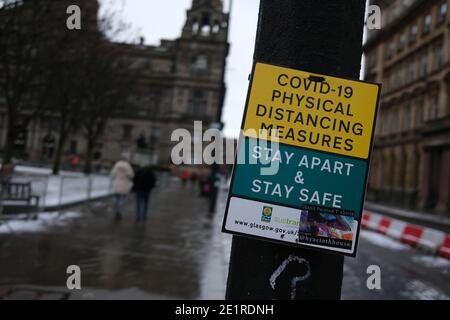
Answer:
81, 9, 141, 174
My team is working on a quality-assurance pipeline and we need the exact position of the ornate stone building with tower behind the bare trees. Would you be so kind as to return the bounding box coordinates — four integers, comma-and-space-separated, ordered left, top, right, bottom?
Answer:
0, 0, 229, 168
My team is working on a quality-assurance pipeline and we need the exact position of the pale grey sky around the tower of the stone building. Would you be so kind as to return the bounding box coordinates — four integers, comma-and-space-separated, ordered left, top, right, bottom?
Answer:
102, 0, 259, 137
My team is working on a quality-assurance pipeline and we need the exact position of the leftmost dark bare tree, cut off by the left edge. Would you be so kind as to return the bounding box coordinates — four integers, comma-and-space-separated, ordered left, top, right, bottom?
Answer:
0, 0, 51, 163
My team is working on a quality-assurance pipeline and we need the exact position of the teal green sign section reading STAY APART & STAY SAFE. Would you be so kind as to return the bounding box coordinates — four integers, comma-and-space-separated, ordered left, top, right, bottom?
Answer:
231, 137, 367, 219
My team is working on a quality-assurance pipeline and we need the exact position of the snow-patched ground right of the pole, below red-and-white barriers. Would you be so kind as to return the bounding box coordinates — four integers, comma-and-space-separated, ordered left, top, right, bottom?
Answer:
342, 230, 450, 300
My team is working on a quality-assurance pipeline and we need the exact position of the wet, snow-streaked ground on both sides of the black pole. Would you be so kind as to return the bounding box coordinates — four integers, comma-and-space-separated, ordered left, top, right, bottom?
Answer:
0, 178, 450, 299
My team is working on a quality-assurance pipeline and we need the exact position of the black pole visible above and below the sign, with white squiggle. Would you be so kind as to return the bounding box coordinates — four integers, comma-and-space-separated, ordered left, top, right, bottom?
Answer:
226, 0, 366, 299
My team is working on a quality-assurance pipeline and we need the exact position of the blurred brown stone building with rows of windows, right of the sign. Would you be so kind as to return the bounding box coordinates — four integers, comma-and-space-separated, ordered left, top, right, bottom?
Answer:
364, 0, 450, 215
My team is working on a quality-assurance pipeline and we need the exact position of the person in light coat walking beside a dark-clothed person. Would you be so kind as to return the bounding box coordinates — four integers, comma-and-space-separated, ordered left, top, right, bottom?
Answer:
111, 160, 134, 220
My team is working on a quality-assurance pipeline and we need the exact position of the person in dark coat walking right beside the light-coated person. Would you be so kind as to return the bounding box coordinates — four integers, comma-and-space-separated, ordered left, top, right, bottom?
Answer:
133, 166, 156, 221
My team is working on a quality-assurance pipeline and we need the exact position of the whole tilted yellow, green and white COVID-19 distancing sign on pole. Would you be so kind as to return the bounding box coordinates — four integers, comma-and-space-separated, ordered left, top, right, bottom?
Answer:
223, 62, 381, 256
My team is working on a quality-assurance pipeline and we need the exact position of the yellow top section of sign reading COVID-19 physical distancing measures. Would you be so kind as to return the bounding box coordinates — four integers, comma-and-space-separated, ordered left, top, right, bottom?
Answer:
243, 63, 380, 159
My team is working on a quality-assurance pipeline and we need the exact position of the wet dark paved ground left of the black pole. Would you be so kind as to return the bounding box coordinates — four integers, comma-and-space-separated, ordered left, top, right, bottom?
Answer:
0, 179, 227, 299
